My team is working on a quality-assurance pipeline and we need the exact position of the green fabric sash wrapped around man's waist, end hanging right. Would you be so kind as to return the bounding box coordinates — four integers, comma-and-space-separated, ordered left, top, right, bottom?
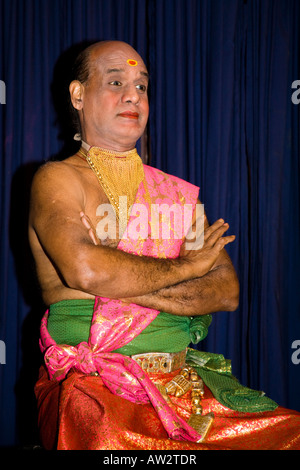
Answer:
48, 300, 278, 413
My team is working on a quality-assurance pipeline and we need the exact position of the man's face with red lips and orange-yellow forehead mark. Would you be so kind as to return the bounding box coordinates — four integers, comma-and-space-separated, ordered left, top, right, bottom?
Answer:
77, 44, 149, 151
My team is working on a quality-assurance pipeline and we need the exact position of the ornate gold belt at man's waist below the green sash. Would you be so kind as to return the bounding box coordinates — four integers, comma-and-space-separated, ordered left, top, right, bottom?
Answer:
131, 349, 187, 374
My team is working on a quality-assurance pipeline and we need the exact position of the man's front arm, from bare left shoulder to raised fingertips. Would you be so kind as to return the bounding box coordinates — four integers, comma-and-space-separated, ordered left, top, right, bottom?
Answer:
29, 162, 234, 298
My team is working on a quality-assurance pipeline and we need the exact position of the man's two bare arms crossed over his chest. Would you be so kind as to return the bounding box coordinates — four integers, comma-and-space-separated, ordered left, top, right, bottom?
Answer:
29, 162, 239, 316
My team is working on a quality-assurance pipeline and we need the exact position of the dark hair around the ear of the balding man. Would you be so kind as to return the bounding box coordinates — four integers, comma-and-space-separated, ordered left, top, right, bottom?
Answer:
69, 47, 90, 133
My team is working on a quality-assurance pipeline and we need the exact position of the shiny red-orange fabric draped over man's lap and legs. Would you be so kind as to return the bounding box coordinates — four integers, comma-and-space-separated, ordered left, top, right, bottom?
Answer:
35, 367, 300, 450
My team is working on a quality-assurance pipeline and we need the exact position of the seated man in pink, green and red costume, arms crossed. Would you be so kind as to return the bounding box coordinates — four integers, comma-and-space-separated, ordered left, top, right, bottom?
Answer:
29, 41, 300, 449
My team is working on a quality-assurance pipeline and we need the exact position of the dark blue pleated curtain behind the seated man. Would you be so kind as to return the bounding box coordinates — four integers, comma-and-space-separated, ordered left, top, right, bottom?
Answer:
0, 0, 300, 446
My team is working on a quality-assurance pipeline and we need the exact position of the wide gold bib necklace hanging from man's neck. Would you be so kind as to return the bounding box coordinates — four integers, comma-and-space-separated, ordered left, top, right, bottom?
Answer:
77, 147, 145, 221
